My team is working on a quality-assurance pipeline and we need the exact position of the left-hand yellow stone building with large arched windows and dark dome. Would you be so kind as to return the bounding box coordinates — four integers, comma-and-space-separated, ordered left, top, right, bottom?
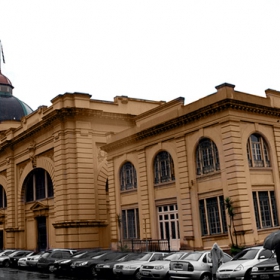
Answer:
0, 69, 165, 250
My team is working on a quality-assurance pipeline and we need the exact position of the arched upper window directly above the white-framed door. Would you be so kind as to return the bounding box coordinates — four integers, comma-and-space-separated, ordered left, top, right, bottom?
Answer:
154, 151, 175, 184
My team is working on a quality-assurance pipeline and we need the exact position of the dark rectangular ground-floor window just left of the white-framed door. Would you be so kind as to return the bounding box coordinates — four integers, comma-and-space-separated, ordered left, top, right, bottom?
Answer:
122, 209, 140, 239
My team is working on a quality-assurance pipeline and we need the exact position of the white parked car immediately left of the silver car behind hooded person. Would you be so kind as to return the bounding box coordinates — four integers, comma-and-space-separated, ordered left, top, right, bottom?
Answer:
140, 251, 191, 279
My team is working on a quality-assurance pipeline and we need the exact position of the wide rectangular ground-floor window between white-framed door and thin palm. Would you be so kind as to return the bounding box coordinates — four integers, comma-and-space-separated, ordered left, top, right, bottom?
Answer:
199, 195, 227, 235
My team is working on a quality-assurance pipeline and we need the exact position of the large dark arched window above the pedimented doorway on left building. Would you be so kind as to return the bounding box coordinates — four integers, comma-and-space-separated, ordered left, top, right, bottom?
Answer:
24, 168, 53, 202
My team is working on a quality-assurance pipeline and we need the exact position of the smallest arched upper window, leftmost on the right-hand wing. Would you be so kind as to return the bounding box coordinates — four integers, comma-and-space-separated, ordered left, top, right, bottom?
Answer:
120, 161, 137, 191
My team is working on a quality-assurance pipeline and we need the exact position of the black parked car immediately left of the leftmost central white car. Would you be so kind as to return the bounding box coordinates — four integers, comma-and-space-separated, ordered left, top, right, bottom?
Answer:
95, 253, 145, 279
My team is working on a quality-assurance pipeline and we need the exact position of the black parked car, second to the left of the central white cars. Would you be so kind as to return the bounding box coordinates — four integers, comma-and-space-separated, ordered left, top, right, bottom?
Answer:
71, 251, 128, 276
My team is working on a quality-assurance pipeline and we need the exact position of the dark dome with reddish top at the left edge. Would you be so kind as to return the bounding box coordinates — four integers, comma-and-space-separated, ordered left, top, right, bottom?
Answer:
0, 70, 33, 122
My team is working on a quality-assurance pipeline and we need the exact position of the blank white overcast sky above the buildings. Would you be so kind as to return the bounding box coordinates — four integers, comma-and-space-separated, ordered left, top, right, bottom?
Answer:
0, 0, 280, 110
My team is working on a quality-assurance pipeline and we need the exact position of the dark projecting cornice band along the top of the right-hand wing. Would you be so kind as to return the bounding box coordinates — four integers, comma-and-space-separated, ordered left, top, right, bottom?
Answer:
102, 99, 280, 152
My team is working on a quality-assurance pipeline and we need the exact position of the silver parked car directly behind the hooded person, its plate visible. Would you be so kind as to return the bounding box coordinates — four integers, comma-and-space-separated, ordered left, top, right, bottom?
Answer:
169, 251, 232, 280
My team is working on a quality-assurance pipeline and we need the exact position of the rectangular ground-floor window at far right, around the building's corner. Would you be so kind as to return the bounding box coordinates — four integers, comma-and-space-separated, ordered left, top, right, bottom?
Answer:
253, 191, 279, 229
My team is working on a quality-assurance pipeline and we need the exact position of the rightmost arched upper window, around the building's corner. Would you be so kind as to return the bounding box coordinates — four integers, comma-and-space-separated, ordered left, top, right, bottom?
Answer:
247, 134, 271, 167
